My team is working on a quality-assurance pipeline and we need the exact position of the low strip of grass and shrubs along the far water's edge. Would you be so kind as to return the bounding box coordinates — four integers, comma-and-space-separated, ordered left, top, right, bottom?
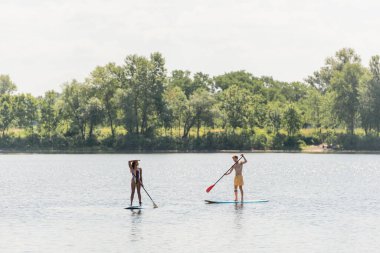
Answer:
0, 128, 380, 153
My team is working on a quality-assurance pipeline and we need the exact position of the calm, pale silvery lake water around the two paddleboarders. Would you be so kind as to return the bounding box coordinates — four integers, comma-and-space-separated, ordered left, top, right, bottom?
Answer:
0, 154, 380, 253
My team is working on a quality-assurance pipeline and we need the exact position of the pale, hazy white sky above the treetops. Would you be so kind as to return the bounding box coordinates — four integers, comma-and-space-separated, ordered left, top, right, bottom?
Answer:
0, 0, 380, 95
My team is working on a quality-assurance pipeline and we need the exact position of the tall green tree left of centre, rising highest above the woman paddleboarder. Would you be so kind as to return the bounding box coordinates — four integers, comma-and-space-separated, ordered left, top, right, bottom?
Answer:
119, 53, 166, 134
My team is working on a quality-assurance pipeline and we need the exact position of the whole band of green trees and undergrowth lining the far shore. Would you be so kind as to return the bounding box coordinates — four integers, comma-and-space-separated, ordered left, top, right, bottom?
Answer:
0, 48, 380, 150
